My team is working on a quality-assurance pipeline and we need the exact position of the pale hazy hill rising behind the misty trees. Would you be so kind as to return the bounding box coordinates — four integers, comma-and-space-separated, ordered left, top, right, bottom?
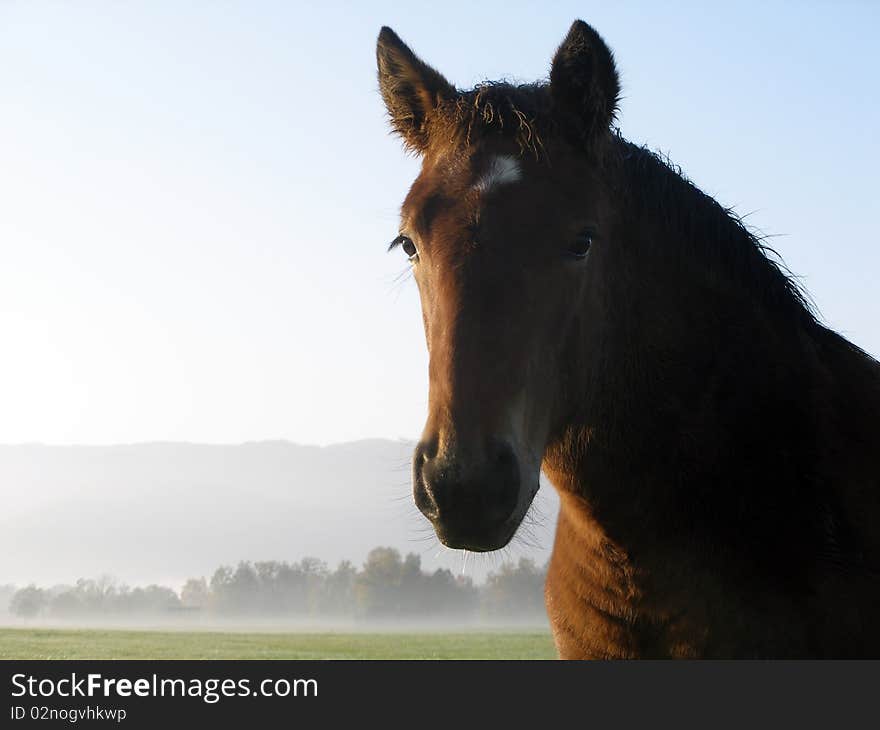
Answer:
0, 439, 556, 585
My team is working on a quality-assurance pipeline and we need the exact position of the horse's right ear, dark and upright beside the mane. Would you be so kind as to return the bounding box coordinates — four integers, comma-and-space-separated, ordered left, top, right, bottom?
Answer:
550, 20, 620, 147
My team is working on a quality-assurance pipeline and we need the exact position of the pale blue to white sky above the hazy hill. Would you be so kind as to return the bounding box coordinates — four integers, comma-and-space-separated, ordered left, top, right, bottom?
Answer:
0, 0, 880, 443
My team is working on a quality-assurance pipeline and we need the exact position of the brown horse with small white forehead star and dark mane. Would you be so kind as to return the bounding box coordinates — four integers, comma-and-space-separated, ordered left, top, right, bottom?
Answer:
377, 21, 880, 658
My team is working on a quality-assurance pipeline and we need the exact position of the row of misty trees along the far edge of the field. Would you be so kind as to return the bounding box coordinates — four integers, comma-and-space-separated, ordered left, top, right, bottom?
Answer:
0, 547, 545, 620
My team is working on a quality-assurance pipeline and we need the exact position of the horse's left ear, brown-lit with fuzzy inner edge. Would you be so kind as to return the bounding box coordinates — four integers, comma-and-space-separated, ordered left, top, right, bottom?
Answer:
376, 27, 456, 152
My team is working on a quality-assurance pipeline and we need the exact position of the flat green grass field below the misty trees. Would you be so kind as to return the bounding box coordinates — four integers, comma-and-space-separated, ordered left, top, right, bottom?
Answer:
0, 629, 556, 659
